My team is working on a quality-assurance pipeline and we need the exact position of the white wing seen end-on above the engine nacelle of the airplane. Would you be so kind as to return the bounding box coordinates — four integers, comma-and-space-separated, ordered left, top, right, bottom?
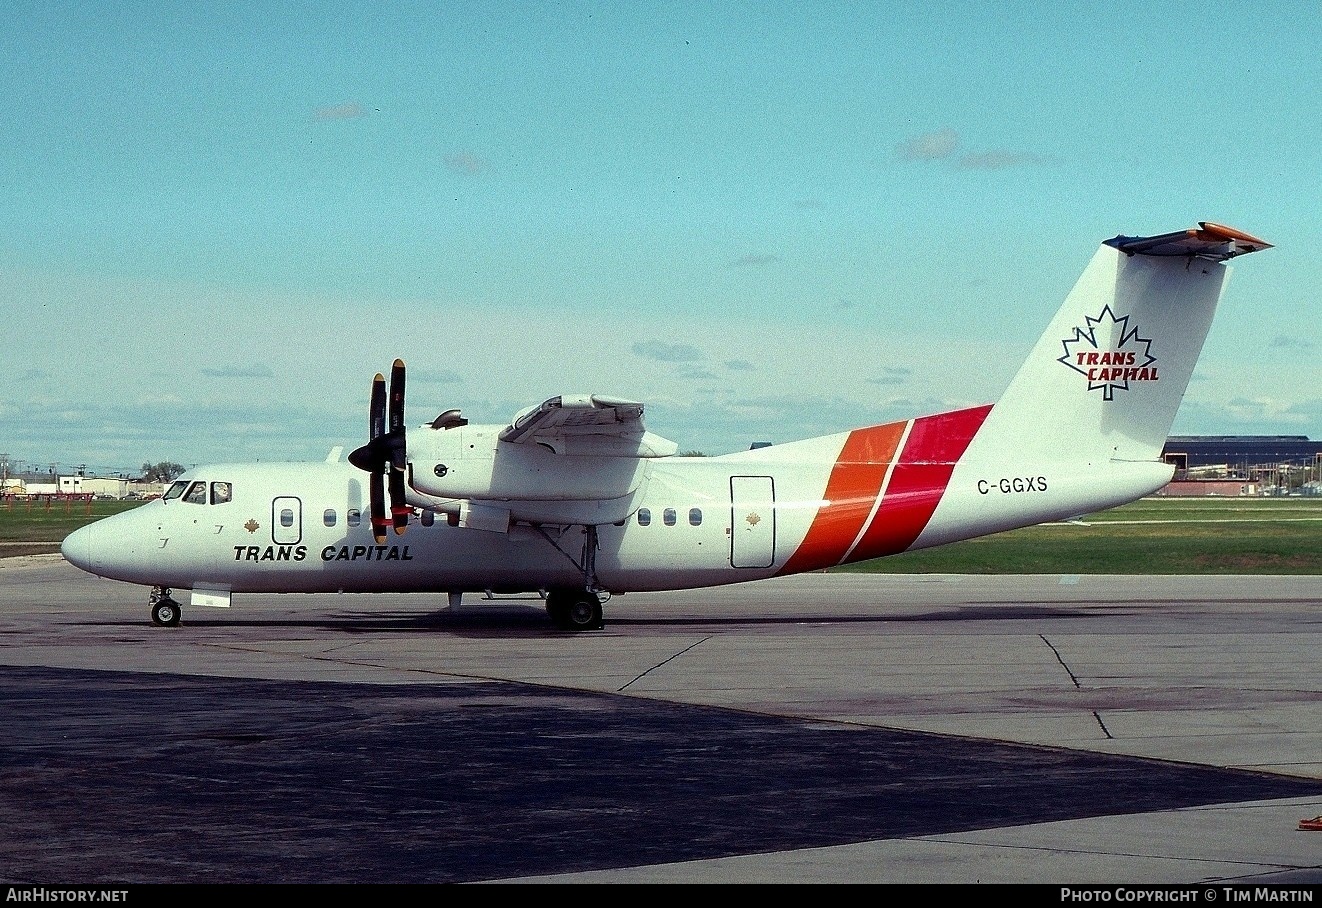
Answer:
500, 394, 680, 457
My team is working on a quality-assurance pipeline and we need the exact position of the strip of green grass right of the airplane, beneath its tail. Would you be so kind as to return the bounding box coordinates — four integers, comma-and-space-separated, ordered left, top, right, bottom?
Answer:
836, 498, 1322, 574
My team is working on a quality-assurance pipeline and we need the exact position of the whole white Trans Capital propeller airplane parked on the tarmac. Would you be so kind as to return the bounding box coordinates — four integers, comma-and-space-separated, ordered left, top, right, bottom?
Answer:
62, 222, 1270, 630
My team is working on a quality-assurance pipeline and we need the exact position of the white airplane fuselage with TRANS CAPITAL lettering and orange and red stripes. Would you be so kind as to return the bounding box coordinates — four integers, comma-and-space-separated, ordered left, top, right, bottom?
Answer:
65, 407, 1169, 592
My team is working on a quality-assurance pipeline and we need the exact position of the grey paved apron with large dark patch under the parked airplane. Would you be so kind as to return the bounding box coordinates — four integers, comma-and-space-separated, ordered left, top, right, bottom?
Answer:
0, 556, 1322, 887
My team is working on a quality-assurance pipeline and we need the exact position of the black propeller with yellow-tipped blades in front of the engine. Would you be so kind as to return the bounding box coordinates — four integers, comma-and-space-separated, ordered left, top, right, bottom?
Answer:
349, 359, 412, 545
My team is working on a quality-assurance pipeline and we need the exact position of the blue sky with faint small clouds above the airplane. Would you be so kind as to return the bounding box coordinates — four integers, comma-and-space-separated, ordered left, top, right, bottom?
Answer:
0, 1, 1322, 472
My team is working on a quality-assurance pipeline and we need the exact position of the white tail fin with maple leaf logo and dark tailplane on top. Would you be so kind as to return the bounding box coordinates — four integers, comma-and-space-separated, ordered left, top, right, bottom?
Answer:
969, 222, 1270, 463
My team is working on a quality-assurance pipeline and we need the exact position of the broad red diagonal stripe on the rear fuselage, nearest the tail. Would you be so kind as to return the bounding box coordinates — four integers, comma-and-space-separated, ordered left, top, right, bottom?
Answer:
849, 404, 992, 562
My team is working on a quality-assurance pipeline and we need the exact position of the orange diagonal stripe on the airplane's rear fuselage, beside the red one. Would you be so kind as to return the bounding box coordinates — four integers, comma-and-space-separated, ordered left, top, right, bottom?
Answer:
777, 423, 906, 574
